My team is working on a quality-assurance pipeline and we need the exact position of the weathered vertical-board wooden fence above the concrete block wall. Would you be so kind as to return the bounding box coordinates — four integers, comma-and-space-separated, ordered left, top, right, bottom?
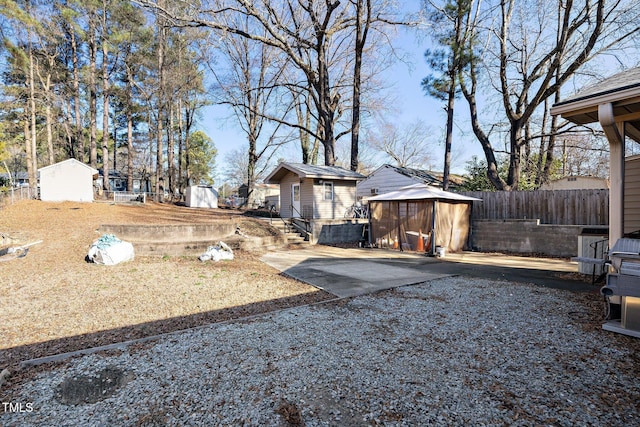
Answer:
461, 190, 609, 225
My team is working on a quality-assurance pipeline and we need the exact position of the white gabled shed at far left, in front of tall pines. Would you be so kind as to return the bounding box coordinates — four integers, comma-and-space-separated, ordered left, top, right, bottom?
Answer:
38, 159, 98, 202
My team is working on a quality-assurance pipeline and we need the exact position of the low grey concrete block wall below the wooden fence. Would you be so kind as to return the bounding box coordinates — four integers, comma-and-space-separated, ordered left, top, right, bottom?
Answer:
470, 219, 584, 257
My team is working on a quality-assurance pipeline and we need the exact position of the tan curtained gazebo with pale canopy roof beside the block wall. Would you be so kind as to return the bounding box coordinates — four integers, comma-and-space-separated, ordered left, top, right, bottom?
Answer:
369, 184, 479, 254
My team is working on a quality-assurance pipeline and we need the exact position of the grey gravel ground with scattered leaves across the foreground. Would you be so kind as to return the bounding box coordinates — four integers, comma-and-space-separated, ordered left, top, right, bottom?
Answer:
0, 277, 640, 426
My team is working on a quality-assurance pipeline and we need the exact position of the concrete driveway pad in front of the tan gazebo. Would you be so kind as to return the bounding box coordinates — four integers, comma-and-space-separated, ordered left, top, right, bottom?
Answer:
261, 245, 599, 297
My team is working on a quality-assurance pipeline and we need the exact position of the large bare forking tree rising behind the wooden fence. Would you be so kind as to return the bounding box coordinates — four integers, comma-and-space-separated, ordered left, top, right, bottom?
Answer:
461, 0, 640, 190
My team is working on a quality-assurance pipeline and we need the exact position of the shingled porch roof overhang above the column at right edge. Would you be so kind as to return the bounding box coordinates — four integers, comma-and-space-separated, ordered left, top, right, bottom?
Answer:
551, 67, 640, 141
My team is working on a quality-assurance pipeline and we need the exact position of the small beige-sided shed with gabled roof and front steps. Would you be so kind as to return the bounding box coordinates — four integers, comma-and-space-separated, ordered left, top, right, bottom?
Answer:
264, 162, 365, 220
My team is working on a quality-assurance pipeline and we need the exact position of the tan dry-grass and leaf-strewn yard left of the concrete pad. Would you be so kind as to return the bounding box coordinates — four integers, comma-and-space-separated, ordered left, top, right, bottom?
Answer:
0, 201, 331, 370
